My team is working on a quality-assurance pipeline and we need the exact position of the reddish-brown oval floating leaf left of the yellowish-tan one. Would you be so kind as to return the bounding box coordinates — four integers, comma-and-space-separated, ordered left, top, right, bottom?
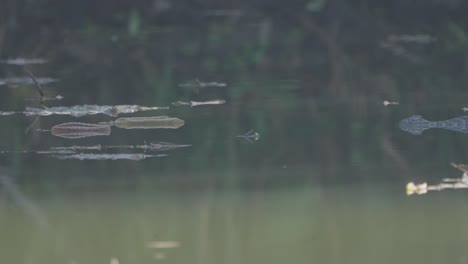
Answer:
50, 122, 111, 139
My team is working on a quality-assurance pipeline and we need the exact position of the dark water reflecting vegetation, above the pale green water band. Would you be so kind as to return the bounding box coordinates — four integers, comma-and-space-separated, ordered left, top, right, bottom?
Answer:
0, 0, 468, 186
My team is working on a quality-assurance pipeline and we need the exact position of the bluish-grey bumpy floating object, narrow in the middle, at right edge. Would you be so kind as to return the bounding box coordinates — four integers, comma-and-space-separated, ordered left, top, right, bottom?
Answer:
399, 115, 468, 135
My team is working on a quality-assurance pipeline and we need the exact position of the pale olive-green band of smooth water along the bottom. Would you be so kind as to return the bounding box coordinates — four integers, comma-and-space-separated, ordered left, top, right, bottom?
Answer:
0, 185, 468, 263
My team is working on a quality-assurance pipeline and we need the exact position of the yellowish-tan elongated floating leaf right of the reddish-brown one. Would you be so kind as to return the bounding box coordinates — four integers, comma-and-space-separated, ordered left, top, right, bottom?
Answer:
103, 116, 185, 129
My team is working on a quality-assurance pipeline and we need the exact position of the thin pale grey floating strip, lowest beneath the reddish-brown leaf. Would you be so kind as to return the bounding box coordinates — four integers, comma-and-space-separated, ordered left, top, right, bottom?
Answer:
50, 153, 167, 160
